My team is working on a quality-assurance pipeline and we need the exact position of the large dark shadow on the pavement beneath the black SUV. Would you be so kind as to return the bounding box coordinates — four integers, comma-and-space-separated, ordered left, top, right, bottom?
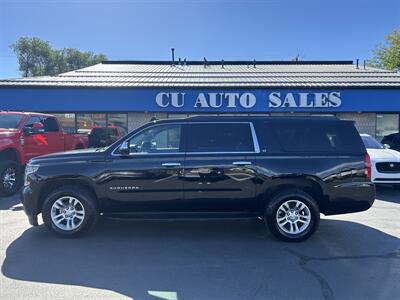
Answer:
2, 219, 400, 300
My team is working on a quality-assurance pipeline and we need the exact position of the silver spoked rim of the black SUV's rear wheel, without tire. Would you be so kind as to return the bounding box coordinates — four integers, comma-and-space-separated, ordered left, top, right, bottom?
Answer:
276, 200, 311, 235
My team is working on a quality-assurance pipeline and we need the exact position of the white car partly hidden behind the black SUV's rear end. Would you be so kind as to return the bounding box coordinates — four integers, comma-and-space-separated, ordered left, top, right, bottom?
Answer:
361, 134, 400, 184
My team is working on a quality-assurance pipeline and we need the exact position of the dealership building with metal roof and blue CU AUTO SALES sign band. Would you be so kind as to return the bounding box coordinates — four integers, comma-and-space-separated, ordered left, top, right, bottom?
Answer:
0, 60, 400, 139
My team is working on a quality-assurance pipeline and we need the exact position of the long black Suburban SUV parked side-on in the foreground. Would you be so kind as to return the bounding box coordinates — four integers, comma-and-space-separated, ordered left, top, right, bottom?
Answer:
23, 116, 375, 241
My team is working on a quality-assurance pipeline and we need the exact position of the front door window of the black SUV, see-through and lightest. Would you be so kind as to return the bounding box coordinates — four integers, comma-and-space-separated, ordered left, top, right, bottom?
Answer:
129, 124, 181, 153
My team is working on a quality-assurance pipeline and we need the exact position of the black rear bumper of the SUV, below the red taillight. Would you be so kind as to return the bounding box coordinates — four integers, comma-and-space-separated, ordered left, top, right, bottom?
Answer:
322, 182, 375, 215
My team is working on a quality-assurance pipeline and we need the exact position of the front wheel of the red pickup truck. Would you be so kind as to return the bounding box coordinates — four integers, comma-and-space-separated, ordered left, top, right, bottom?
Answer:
0, 160, 22, 196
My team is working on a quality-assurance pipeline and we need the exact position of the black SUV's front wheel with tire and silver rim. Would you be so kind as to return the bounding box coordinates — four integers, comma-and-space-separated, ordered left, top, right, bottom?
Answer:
42, 185, 99, 238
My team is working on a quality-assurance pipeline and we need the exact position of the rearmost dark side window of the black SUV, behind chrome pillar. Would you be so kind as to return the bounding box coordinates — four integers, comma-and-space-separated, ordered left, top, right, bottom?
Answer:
273, 120, 365, 153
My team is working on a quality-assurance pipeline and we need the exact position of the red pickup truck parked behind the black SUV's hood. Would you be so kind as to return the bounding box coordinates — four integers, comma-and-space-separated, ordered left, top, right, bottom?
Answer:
0, 112, 88, 196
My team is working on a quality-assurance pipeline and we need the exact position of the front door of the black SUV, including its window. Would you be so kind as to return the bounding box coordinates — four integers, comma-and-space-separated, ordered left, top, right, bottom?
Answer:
103, 124, 185, 212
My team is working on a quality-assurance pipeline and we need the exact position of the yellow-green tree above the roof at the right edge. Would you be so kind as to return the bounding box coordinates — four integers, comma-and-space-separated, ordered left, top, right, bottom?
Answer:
368, 29, 400, 71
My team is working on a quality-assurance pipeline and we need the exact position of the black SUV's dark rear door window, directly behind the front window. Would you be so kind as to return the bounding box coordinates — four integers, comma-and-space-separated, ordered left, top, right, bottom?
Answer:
186, 123, 254, 152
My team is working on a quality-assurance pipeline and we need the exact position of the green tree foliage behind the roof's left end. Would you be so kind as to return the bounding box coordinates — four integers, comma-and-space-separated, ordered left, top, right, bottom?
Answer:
11, 37, 107, 77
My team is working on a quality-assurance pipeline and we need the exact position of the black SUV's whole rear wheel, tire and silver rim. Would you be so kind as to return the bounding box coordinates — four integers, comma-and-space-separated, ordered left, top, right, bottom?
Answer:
264, 189, 320, 242
